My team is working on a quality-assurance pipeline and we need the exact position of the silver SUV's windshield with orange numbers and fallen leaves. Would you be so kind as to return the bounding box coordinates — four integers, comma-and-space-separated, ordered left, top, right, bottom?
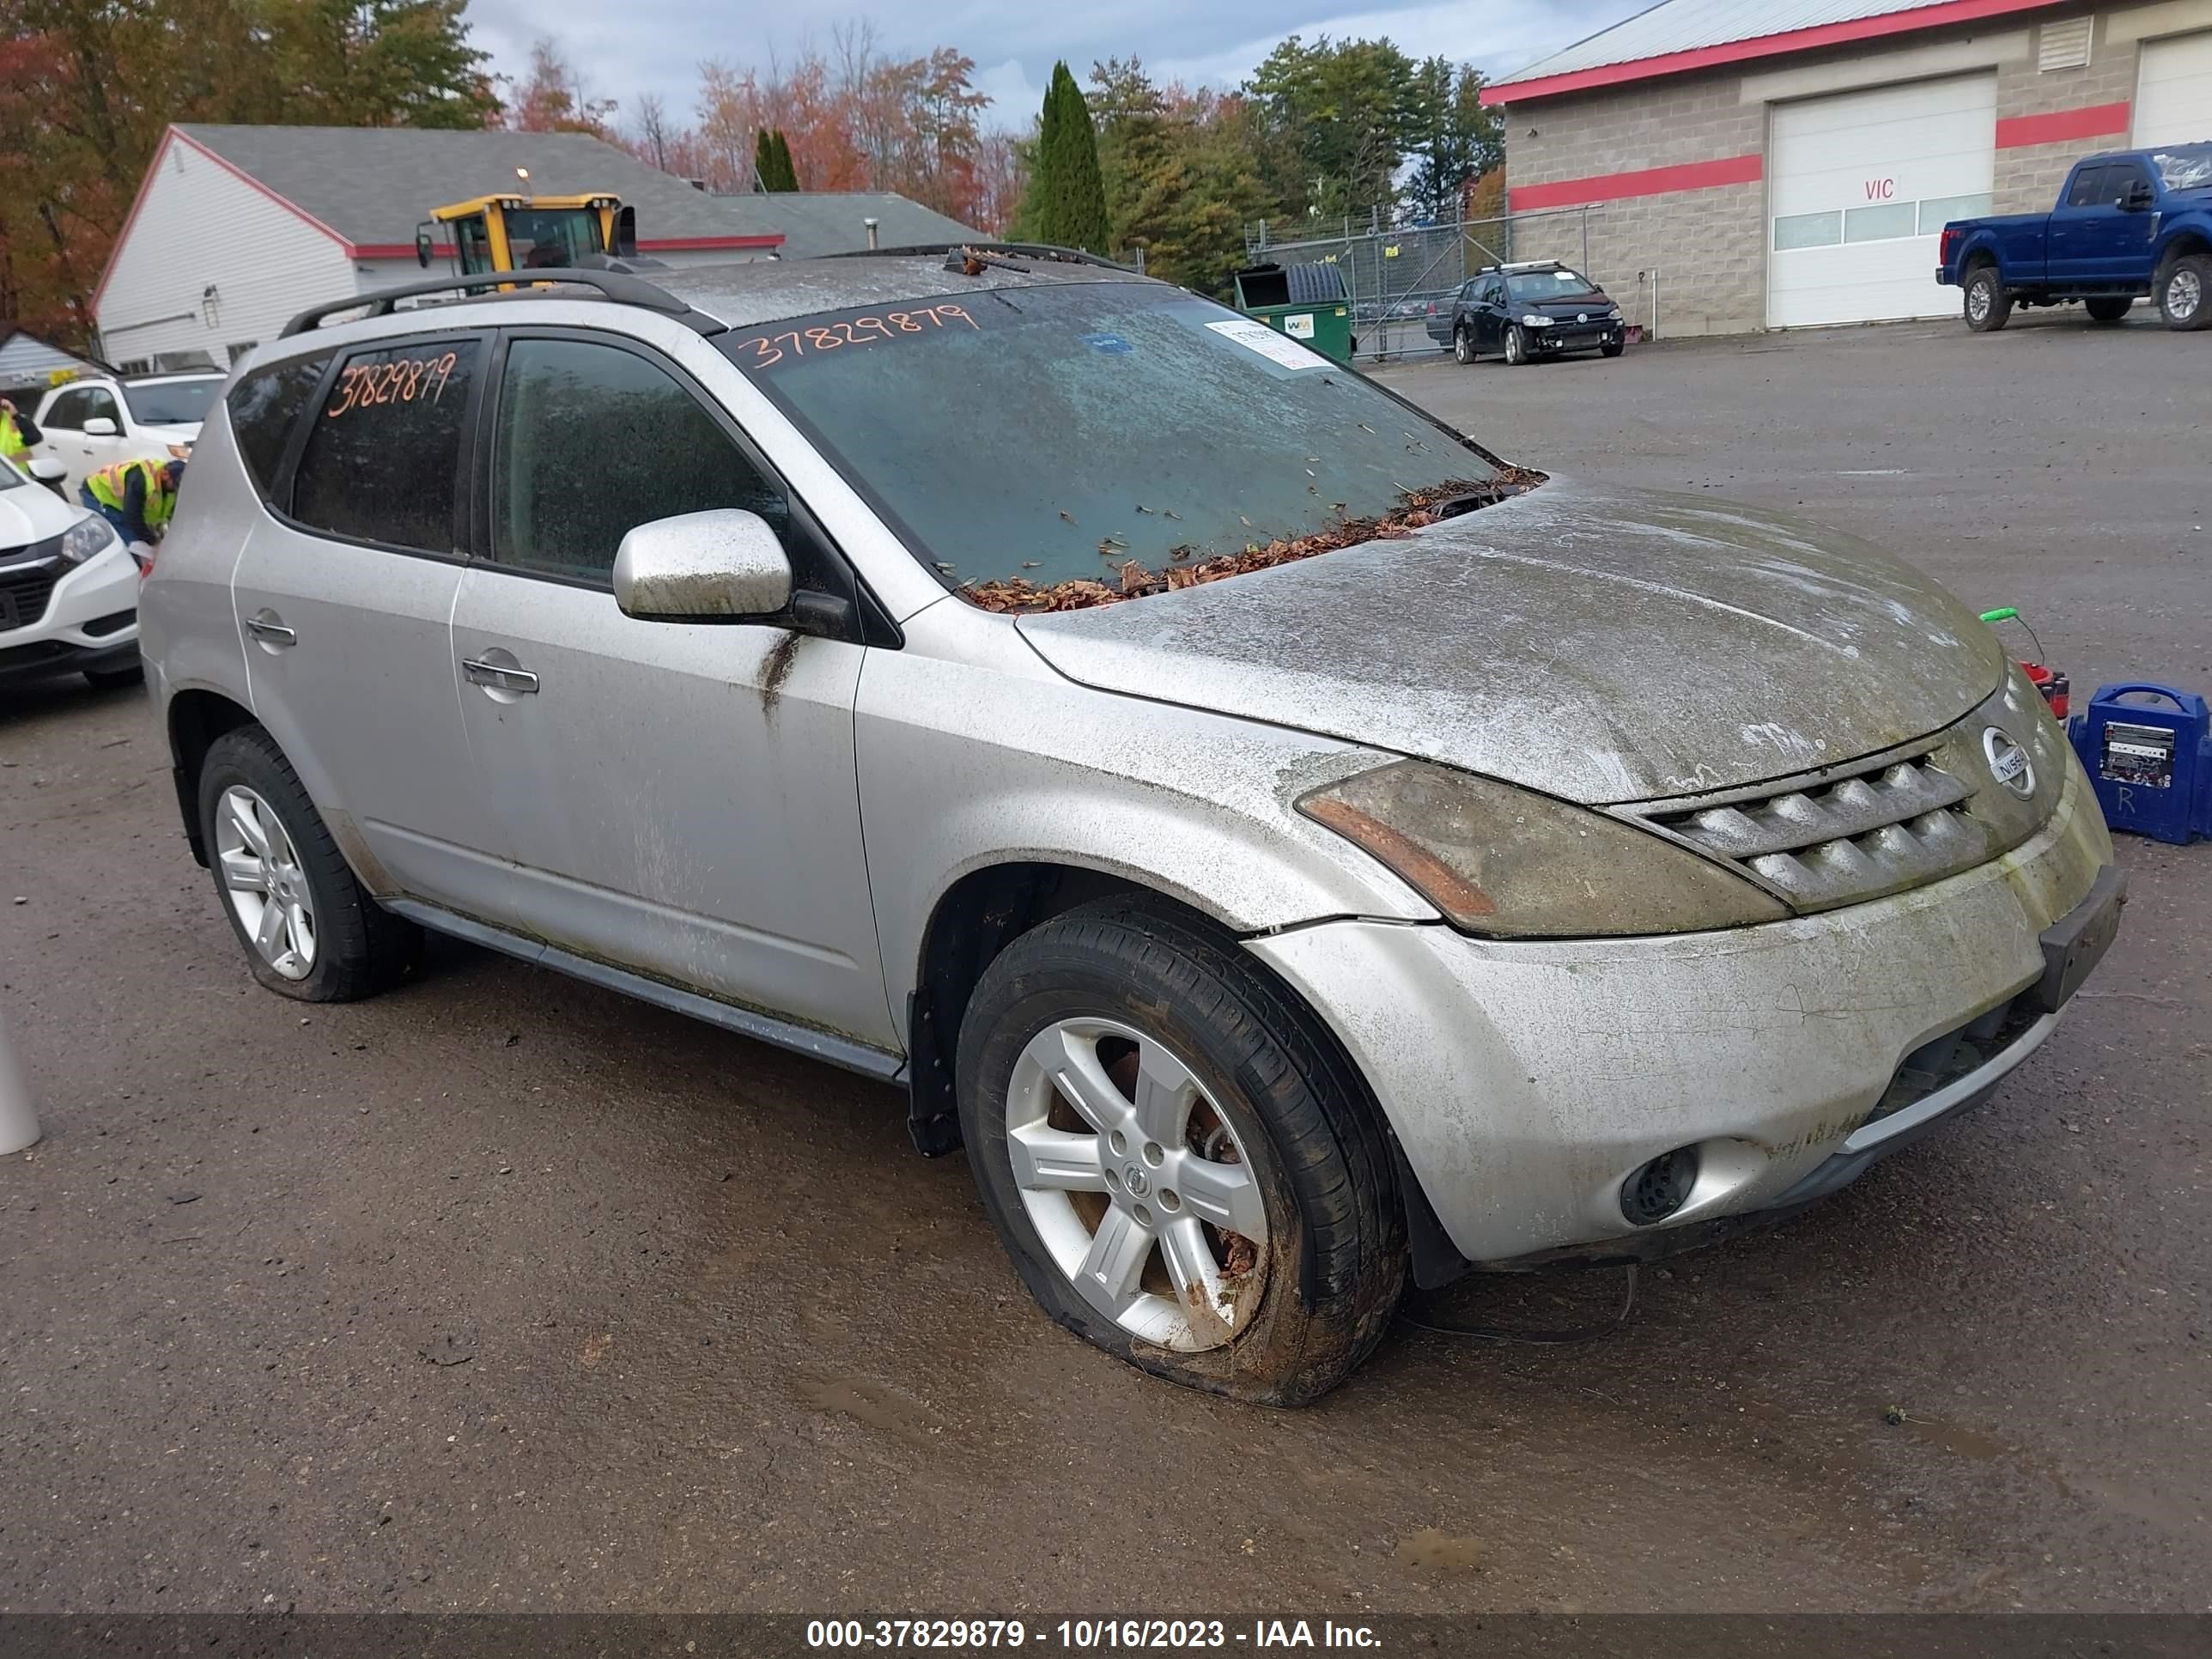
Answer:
719, 283, 1498, 598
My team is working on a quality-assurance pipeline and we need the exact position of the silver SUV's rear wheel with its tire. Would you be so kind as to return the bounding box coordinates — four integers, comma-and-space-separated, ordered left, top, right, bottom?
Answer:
199, 726, 422, 1002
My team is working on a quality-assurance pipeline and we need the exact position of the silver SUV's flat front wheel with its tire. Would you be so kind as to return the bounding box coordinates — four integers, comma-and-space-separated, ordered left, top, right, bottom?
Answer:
960, 900, 1405, 1405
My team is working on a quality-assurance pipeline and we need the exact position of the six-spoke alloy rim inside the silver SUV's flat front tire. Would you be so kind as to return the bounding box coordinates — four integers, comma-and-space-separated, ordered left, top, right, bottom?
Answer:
1006, 1020, 1267, 1354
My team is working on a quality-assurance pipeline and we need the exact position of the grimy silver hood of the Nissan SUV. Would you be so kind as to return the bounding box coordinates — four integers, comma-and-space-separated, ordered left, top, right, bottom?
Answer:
1018, 477, 2004, 803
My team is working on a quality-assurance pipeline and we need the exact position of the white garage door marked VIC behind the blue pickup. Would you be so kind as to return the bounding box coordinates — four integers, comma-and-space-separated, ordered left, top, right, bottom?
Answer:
1767, 76, 1997, 327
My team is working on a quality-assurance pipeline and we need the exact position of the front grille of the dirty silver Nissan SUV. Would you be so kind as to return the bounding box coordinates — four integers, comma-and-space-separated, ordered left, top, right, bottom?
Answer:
1626, 681, 2066, 911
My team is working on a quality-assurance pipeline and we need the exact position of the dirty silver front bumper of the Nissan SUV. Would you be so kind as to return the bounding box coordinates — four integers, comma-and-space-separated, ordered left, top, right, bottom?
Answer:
1248, 763, 2112, 1265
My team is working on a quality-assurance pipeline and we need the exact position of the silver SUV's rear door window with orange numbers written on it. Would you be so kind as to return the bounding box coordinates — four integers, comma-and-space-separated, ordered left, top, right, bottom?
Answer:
292, 338, 482, 556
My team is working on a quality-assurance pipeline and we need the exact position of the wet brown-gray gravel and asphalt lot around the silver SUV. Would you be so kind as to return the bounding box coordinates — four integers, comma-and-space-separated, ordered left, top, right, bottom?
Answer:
0, 314, 2212, 1617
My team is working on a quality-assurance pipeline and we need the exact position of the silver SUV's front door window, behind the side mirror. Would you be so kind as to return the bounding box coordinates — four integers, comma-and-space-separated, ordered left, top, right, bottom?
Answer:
491, 338, 790, 584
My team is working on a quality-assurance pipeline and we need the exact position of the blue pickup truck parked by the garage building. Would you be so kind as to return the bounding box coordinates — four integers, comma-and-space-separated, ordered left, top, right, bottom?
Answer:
1936, 143, 2212, 334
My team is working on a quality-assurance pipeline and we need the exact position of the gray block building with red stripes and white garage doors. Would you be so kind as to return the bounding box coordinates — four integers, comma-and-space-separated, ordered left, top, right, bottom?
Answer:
1484, 0, 2212, 334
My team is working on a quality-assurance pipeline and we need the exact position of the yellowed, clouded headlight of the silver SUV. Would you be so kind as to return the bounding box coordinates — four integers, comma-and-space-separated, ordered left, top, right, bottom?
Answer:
1297, 761, 1790, 938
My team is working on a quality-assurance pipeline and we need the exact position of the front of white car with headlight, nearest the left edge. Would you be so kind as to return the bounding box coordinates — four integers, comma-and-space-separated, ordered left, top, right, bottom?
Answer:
0, 451, 139, 686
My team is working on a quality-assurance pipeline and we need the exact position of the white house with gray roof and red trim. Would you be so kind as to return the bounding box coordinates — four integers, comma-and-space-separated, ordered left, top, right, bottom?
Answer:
93, 126, 975, 372
